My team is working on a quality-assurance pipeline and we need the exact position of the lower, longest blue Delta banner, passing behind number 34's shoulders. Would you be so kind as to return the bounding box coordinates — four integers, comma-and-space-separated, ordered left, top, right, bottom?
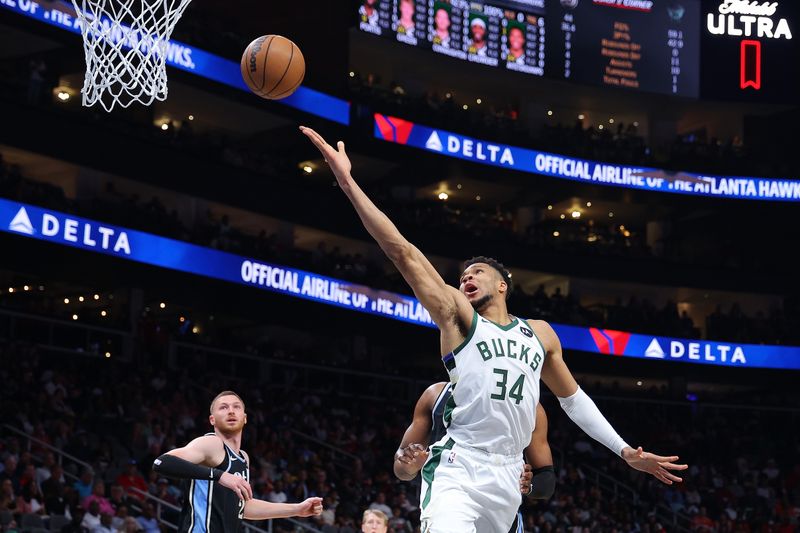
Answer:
0, 199, 800, 370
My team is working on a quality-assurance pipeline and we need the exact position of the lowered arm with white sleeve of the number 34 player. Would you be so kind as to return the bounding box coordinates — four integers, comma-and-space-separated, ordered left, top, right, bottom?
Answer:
528, 320, 688, 485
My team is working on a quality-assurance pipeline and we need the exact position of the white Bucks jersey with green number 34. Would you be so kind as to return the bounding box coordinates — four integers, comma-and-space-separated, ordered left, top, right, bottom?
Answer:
443, 313, 545, 455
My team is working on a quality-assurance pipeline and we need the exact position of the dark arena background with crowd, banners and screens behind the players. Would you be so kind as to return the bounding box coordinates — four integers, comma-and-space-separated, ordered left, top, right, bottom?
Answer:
0, 0, 800, 533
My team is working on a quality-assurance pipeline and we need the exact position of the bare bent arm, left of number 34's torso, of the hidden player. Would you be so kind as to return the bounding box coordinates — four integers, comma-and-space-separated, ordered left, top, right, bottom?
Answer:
394, 382, 447, 481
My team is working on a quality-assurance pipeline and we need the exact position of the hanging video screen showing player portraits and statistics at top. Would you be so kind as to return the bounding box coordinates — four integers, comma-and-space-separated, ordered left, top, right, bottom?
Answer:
358, 0, 700, 97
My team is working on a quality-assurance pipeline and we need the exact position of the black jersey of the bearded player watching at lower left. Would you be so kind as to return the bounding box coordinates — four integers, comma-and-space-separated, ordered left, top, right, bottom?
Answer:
178, 433, 250, 533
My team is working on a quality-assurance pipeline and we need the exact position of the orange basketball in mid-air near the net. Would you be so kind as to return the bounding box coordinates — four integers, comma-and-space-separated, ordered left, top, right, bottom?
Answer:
242, 35, 306, 100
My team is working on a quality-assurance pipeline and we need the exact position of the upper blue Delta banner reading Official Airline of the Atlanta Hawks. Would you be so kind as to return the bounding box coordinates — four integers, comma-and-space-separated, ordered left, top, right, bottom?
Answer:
374, 113, 800, 202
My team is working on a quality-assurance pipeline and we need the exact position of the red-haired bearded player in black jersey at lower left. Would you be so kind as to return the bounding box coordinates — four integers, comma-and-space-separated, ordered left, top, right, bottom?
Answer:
153, 391, 322, 533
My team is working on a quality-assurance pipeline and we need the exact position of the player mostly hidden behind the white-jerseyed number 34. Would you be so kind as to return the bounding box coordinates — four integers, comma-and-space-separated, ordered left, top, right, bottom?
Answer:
394, 381, 556, 533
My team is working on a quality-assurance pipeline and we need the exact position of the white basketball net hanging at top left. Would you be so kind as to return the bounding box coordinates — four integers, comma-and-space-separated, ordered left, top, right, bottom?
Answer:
72, 0, 191, 111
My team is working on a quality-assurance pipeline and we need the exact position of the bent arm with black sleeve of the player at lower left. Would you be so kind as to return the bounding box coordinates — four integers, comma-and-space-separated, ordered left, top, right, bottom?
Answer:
153, 435, 253, 500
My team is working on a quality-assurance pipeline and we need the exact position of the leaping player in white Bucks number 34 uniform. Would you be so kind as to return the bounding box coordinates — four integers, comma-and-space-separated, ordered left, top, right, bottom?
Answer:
300, 127, 687, 533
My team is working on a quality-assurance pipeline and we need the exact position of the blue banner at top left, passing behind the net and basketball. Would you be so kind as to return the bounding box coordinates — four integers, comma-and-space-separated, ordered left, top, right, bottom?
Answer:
0, 0, 350, 125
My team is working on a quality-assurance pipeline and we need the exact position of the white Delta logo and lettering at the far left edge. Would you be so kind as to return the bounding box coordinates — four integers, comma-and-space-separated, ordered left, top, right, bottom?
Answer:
8, 207, 131, 255
